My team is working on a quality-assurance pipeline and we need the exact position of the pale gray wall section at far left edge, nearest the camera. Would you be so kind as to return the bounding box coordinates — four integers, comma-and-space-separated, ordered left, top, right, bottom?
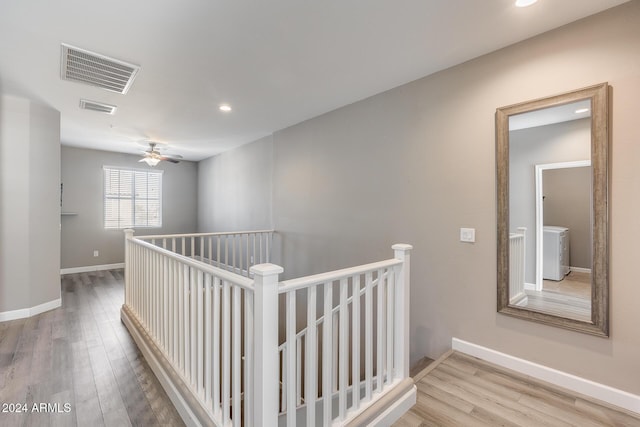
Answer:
0, 95, 60, 313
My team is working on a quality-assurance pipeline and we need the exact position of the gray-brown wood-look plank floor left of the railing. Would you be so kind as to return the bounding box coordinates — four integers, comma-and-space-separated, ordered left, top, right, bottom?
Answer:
0, 270, 184, 427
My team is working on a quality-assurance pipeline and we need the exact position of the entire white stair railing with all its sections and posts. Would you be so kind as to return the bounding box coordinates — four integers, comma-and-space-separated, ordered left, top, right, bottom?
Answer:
122, 230, 415, 426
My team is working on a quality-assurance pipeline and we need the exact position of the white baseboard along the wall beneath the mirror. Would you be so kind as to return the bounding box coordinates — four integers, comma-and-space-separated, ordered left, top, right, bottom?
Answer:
451, 338, 640, 414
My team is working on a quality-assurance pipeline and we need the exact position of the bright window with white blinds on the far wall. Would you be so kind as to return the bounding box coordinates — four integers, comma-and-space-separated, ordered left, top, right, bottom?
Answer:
104, 166, 162, 228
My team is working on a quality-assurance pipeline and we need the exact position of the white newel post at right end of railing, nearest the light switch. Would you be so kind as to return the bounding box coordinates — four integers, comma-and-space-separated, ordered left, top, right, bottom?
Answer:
391, 243, 413, 379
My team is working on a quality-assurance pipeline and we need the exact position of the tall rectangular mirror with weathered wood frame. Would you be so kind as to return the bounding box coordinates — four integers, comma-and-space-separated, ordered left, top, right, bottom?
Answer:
496, 83, 609, 337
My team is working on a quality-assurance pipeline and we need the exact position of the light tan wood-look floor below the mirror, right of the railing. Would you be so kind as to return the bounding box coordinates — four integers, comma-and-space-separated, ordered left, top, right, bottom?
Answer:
395, 352, 640, 427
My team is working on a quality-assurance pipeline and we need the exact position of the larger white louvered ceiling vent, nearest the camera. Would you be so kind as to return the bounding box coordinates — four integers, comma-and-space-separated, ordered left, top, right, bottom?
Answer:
60, 43, 140, 94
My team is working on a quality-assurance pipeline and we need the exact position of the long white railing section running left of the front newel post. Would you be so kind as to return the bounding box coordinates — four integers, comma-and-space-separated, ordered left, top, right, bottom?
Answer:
123, 230, 256, 426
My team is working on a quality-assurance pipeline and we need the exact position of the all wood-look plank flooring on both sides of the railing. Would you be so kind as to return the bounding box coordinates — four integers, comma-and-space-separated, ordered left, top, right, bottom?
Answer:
6, 270, 640, 427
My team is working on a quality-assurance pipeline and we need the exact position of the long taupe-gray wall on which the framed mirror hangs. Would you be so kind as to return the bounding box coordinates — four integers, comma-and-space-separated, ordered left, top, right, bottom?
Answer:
200, 1, 640, 394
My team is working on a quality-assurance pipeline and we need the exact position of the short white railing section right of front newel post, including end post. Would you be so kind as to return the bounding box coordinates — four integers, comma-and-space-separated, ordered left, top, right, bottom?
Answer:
278, 245, 411, 426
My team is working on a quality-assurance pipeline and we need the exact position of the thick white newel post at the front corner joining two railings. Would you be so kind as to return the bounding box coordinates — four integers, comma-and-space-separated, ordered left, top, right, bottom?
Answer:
248, 264, 284, 427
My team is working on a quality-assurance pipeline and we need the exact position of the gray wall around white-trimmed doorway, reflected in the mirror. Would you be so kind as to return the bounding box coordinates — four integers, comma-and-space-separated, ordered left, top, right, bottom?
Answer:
509, 119, 591, 283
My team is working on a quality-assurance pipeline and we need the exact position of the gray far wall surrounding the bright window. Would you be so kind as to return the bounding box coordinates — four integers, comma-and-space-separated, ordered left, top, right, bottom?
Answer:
61, 146, 198, 268
